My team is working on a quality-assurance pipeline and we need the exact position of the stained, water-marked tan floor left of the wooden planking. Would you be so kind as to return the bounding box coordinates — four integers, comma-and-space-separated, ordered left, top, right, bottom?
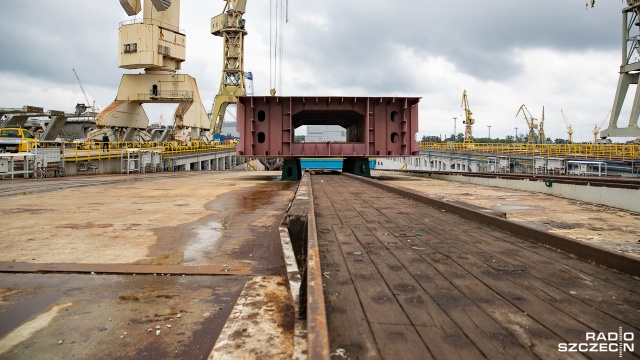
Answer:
0, 171, 295, 359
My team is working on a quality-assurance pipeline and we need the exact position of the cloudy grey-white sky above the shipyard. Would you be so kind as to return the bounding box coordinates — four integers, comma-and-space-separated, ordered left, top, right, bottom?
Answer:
0, 0, 630, 141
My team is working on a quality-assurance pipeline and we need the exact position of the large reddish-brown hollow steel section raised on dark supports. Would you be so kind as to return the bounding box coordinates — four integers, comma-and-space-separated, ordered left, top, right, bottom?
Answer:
236, 96, 420, 157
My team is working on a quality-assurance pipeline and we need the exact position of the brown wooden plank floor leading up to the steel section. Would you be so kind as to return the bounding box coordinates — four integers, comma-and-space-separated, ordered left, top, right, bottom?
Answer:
311, 175, 640, 359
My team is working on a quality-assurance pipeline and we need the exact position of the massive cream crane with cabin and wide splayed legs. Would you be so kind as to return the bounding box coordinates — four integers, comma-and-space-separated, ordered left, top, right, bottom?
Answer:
87, 0, 211, 143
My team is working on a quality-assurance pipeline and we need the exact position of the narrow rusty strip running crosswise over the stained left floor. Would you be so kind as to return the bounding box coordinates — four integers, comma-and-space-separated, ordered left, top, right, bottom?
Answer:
0, 262, 251, 275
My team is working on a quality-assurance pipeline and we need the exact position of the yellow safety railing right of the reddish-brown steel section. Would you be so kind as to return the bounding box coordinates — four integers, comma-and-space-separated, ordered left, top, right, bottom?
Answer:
420, 142, 640, 161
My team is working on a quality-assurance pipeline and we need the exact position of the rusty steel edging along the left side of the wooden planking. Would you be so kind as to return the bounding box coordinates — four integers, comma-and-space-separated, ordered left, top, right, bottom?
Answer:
300, 173, 330, 359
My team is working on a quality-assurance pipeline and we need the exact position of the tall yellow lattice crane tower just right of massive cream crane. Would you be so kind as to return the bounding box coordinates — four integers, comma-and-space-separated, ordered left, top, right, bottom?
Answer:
210, 0, 247, 135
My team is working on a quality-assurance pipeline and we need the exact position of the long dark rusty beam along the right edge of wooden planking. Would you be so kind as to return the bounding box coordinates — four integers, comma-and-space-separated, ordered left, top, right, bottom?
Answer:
343, 173, 640, 276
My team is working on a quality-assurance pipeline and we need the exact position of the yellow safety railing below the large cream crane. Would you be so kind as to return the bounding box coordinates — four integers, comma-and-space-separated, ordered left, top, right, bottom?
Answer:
40, 141, 236, 162
